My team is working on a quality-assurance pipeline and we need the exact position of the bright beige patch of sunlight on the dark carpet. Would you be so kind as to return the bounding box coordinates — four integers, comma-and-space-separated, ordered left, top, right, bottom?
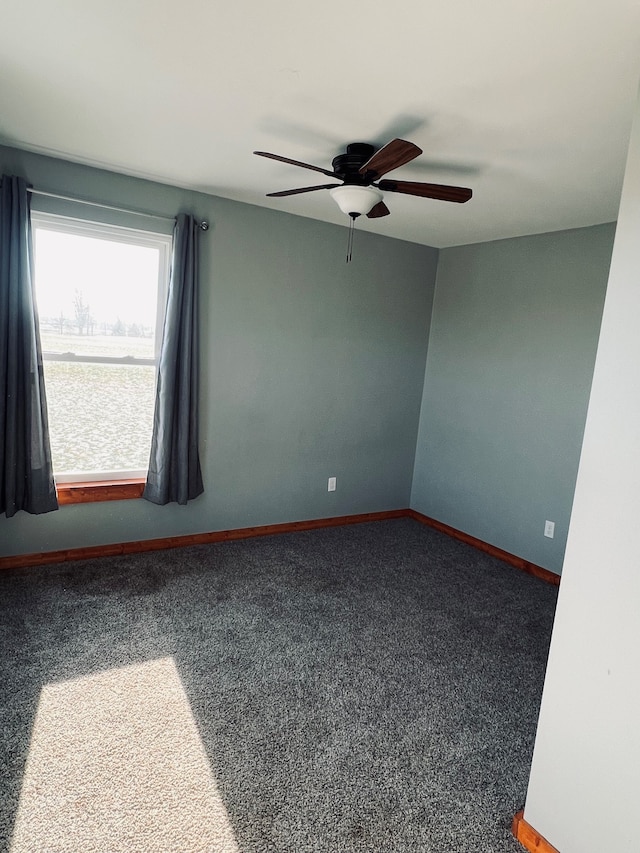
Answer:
11, 658, 239, 853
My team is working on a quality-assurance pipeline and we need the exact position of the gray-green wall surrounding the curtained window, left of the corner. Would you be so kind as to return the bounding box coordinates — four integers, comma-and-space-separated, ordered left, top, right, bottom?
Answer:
0, 148, 438, 555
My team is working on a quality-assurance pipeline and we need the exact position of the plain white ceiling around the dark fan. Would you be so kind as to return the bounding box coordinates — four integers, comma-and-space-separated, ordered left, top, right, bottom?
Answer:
0, 0, 640, 247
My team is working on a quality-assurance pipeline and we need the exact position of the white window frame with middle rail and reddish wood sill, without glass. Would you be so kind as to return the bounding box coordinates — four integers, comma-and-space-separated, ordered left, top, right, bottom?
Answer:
31, 210, 173, 504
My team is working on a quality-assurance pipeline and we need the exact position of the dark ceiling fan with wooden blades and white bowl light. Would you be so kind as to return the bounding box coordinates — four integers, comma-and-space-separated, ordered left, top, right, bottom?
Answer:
253, 139, 472, 220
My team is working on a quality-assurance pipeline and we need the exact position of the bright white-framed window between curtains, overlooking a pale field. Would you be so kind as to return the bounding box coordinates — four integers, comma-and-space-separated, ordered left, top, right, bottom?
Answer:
32, 213, 171, 492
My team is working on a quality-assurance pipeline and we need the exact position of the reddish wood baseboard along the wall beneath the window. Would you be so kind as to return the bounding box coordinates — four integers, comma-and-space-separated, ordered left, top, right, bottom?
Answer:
0, 509, 407, 569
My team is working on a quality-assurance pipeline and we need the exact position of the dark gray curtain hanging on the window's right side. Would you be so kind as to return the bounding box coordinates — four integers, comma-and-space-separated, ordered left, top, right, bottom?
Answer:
143, 214, 204, 504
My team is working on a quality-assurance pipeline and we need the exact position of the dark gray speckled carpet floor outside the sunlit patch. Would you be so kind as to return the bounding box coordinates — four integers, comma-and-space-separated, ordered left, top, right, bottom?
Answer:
0, 519, 556, 853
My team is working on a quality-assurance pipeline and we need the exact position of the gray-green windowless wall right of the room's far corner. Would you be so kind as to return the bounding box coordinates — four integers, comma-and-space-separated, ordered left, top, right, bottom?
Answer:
411, 225, 615, 572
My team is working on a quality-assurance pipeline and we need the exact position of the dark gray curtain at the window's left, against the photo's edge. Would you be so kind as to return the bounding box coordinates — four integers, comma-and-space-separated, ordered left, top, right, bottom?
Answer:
0, 175, 58, 518
